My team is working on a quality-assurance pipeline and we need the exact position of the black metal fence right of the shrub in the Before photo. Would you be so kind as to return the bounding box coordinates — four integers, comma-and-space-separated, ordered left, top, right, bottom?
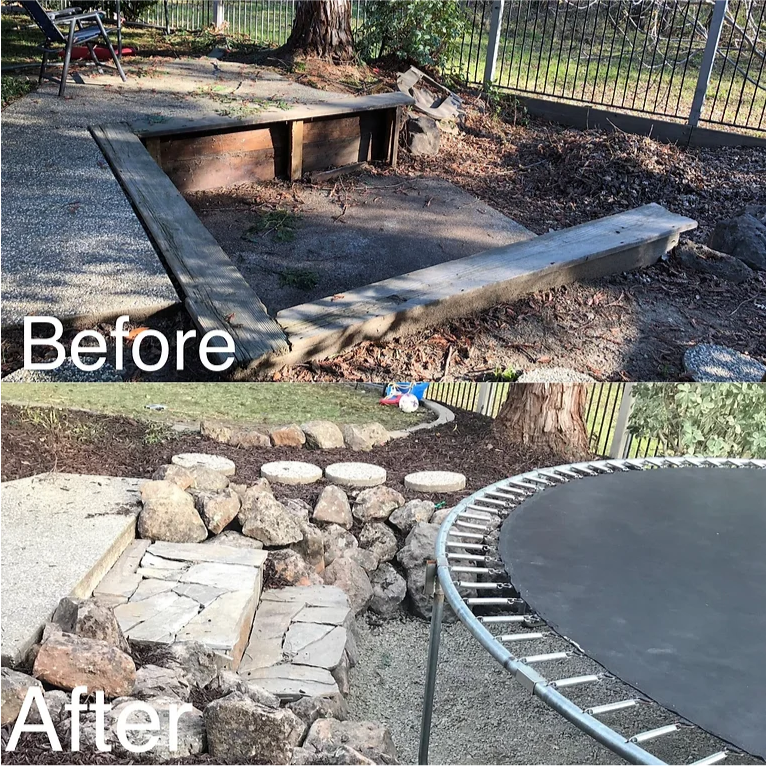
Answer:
454, 0, 766, 131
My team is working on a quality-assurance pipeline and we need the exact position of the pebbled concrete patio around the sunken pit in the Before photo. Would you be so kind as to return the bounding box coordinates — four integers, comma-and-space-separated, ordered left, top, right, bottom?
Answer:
1, 58, 338, 327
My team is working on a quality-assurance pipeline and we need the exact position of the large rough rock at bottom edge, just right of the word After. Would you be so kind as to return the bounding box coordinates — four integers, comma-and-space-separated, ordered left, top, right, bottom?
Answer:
205, 692, 306, 766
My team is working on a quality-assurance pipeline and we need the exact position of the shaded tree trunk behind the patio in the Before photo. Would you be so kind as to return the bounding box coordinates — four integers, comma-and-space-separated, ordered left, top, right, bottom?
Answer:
285, 0, 354, 61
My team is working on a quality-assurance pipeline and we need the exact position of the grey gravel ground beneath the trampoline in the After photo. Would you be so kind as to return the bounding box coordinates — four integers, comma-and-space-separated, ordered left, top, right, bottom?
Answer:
349, 618, 761, 766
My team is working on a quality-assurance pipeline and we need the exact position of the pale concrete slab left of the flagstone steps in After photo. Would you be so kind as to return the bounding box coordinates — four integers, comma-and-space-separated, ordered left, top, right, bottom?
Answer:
0, 473, 141, 665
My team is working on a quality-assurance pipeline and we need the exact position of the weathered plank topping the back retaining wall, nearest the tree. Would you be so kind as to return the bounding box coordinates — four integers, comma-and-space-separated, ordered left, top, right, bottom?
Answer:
135, 91, 415, 138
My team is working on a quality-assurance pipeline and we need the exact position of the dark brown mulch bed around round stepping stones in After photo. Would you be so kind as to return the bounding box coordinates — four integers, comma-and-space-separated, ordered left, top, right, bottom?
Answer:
0, 406, 567, 505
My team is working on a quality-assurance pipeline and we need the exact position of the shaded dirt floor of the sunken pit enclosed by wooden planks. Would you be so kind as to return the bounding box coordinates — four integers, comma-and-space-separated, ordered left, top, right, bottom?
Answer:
189, 172, 532, 314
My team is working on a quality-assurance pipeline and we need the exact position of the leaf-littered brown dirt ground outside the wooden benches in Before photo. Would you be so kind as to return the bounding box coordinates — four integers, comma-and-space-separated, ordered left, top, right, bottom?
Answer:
260, 62, 766, 380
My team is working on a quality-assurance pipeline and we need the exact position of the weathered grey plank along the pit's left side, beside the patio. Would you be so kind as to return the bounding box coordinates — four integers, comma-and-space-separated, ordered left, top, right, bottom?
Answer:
90, 123, 288, 365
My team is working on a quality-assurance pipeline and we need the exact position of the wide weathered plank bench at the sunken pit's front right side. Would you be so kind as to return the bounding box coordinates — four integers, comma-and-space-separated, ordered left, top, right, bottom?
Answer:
272, 204, 697, 369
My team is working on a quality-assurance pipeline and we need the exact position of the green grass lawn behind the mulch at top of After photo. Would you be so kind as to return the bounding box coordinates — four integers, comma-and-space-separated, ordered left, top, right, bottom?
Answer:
0, 383, 433, 430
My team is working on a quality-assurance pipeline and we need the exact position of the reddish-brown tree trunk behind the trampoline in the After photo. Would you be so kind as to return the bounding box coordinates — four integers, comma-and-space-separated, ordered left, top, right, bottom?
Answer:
494, 383, 591, 462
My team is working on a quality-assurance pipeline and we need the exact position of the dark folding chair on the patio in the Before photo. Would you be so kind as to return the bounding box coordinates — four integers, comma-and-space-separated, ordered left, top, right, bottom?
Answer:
21, 0, 126, 96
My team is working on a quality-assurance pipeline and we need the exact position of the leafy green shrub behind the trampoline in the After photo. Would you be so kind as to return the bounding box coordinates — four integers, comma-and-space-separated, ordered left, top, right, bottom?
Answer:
628, 383, 766, 458
